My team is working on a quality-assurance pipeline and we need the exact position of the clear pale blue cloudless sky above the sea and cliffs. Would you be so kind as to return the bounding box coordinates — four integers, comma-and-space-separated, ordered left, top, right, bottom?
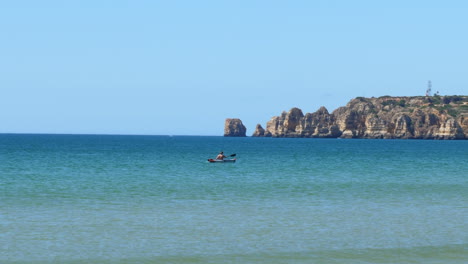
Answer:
0, 0, 468, 135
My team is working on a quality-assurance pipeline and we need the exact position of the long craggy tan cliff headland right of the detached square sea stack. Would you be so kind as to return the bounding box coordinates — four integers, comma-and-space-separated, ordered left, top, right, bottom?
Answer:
252, 96, 468, 139
